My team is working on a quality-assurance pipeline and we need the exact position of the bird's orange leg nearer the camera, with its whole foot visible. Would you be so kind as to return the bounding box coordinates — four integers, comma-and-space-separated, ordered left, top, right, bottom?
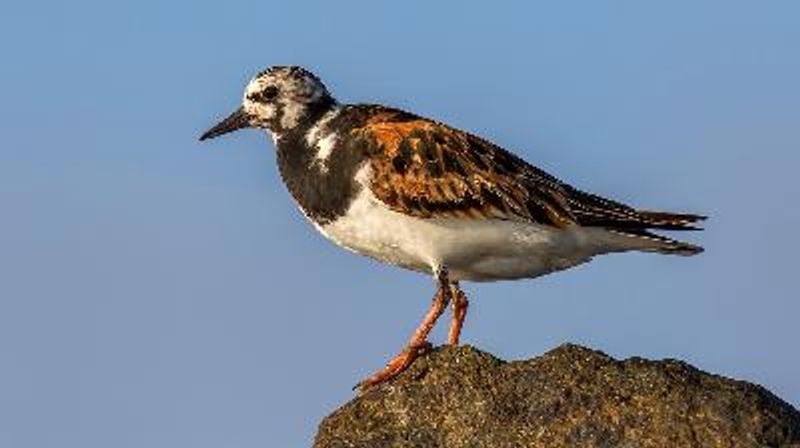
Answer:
355, 270, 452, 392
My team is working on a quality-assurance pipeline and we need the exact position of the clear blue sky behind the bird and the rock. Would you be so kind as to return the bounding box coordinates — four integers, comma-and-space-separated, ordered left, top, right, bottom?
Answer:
0, 1, 800, 448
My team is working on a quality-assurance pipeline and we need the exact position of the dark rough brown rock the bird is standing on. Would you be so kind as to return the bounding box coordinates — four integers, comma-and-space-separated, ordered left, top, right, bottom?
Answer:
314, 344, 800, 448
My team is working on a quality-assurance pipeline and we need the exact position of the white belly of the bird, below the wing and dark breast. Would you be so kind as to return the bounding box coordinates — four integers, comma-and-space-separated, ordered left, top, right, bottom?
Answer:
318, 189, 598, 281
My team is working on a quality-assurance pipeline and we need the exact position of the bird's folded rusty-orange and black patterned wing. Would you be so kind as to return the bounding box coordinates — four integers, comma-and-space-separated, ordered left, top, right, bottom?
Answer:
346, 109, 577, 227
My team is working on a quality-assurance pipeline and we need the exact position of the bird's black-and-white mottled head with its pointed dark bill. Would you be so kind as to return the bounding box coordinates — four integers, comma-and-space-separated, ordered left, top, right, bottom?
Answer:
200, 66, 336, 141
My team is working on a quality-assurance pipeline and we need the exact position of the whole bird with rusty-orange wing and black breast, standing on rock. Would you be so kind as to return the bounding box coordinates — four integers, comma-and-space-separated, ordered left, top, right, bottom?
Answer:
200, 66, 706, 391
